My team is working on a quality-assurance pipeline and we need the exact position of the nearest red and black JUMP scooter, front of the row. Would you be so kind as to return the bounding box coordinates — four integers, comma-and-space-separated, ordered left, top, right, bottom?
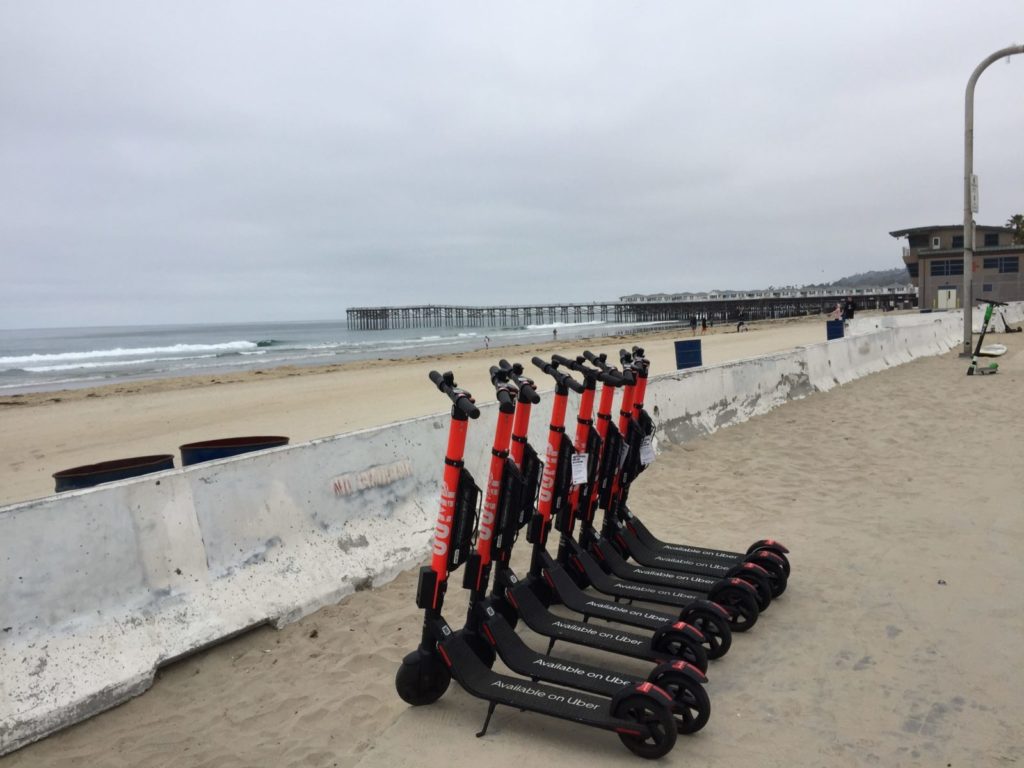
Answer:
395, 371, 676, 758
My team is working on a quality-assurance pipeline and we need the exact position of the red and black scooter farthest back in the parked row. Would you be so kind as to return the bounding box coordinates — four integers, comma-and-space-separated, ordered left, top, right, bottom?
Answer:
605, 347, 791, 597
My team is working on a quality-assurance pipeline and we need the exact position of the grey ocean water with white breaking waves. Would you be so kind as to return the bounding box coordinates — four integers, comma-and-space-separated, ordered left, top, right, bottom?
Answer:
0, 321, 672, 395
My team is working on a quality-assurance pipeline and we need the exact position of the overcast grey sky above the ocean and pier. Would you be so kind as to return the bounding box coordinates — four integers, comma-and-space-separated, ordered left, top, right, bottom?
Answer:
0, 0, 1024, 328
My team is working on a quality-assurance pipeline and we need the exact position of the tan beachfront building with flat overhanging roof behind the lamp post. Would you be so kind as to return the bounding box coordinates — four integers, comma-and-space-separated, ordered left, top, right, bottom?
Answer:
889, 224, 1024, 309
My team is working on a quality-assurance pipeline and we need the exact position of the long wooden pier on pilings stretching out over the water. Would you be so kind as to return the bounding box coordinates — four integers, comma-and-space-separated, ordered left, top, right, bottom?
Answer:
345, 286, 918, 331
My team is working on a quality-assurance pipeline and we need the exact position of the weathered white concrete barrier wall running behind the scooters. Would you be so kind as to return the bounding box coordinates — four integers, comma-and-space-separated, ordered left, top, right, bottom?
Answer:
0, 304, 1007, 754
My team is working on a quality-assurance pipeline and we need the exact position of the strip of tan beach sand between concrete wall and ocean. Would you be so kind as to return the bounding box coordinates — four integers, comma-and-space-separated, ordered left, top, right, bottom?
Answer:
0, 317, 824, 506
